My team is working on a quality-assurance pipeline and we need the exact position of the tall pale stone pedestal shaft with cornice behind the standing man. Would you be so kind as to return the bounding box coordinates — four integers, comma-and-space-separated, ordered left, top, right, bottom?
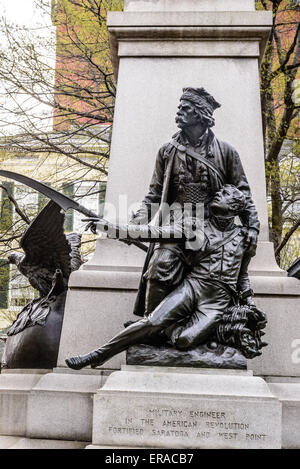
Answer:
106, 0, 272, 234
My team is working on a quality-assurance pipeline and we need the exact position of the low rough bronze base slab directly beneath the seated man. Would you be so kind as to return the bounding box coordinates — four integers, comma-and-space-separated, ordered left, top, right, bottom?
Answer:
126, 344, 247, 369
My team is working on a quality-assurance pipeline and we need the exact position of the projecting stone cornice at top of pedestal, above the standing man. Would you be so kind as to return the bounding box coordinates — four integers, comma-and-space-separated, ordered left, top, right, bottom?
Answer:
107, 11, 272, 75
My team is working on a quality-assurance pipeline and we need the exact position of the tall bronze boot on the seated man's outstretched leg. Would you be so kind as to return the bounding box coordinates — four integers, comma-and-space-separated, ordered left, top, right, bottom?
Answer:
66, 318, 155, 370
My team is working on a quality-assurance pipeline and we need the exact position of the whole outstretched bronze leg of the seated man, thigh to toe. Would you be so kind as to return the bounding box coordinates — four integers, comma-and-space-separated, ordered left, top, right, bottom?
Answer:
66, 282, 194, 370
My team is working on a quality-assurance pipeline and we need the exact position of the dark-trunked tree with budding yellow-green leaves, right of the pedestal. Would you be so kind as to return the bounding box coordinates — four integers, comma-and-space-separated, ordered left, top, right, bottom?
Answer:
256, 0, 300, 267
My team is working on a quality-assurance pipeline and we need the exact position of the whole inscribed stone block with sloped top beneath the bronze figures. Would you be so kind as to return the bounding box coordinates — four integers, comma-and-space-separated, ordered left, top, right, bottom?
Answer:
93, 366, 281, 449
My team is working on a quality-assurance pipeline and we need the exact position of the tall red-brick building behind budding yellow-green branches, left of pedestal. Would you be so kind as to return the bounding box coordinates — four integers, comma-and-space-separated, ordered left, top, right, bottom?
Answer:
53, 0, 123, 129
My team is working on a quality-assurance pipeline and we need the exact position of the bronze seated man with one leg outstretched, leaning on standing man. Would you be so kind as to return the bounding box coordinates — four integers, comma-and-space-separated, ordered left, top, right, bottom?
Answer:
66, 185, 266, 370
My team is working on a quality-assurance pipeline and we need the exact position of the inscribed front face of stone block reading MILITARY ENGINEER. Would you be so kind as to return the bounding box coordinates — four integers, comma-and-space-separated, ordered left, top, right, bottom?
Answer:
93, 371, 281, 449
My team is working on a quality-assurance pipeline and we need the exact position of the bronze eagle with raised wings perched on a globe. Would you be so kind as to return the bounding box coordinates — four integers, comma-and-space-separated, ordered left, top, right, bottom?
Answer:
2, 200, 83, 368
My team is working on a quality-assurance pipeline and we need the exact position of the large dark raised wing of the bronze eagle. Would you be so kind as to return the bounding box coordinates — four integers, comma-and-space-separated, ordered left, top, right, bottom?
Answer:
20, 201, 71, 279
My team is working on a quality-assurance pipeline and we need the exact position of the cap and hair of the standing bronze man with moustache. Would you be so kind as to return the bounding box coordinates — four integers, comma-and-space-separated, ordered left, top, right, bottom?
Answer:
180, 87, 221, 127
